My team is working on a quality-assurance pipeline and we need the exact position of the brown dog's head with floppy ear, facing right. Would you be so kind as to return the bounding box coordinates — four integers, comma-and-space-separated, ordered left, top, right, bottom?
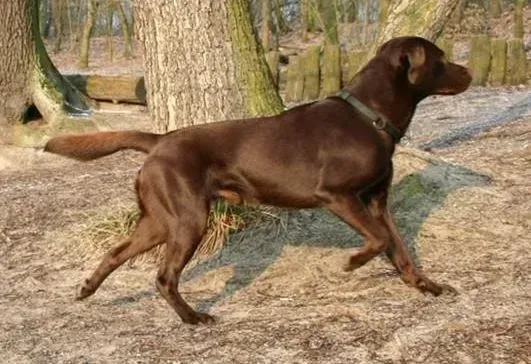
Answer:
376, 37, 472, 97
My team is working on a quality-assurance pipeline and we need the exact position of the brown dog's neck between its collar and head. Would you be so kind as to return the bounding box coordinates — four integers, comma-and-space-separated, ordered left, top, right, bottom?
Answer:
344, 58, 422, 135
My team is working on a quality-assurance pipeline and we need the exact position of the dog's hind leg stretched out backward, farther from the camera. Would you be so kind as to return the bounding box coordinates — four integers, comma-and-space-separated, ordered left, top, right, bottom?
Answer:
76, 214, 165, 300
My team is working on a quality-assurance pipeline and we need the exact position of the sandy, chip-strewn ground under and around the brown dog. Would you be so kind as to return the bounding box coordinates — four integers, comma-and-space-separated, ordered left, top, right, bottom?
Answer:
0, 89, 531, 364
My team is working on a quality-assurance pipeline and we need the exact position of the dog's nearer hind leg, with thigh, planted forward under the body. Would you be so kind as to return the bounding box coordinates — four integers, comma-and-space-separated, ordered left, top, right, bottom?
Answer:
137, 156, 218, 324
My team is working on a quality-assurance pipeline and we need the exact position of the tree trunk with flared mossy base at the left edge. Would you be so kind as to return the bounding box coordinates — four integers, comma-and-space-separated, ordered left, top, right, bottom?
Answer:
0, 0, 90, 125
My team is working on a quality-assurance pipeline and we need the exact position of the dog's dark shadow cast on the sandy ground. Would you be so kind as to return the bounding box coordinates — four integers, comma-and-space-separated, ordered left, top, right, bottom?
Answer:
183, 161, 489, 311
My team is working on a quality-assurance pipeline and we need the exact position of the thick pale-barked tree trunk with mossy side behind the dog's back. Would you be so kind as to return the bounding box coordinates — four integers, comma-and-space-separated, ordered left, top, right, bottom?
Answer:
134, 0, 283, 132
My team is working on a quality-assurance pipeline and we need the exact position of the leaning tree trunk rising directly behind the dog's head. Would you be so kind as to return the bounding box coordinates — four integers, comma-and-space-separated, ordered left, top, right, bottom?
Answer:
360, 0, 459, 70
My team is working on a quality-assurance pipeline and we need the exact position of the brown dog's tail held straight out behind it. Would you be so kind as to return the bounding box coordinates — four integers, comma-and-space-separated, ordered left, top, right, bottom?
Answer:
44, 131, 162, 161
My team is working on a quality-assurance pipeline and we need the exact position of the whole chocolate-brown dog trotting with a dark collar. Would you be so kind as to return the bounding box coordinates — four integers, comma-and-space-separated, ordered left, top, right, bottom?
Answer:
45, 37, 471, 324
